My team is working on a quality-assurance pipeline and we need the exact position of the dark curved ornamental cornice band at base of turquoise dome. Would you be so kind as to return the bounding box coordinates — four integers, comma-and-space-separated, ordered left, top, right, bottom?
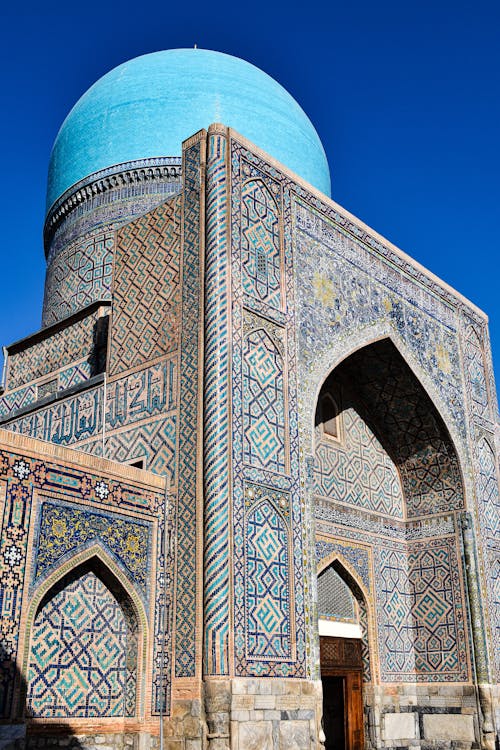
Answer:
43, 156, 182, 252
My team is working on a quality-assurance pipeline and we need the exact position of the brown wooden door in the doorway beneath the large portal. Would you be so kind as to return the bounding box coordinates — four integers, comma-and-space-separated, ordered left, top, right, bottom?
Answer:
320, 636, 364, 750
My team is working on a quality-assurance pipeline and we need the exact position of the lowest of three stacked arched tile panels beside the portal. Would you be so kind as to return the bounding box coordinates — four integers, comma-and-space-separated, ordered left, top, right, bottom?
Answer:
245, 487, 291, 660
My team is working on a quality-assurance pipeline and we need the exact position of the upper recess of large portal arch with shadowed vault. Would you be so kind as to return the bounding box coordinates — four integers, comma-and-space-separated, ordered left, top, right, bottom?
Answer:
314, 339, 464, 521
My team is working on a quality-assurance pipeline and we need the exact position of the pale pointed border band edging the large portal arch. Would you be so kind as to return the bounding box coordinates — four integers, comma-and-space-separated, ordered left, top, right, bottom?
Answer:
299, 321, 474, 509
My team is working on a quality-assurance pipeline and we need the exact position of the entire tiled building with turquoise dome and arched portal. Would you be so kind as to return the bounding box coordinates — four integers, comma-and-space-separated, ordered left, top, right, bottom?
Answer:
0, 50, 500, 750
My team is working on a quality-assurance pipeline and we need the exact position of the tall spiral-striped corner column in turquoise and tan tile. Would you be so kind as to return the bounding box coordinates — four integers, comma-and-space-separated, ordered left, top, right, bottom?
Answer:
204, 134, 230, 674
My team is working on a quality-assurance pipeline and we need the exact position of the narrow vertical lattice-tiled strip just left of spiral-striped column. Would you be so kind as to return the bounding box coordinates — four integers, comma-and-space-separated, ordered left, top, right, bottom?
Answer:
174, 141, 204, 677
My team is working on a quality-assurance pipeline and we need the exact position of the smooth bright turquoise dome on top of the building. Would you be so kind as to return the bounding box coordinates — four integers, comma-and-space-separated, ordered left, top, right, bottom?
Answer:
47, 49, 330, 208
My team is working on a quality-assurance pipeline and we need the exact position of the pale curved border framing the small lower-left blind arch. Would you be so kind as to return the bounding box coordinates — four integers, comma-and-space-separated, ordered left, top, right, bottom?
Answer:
19, 544, 149, 717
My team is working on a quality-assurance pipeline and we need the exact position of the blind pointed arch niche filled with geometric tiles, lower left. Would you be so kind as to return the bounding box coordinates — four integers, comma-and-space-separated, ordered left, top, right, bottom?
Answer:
26, 554, 144, 719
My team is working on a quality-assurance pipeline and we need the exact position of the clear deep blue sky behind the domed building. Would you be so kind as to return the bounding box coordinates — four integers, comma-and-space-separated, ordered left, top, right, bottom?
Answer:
0, 0, 500, 418
